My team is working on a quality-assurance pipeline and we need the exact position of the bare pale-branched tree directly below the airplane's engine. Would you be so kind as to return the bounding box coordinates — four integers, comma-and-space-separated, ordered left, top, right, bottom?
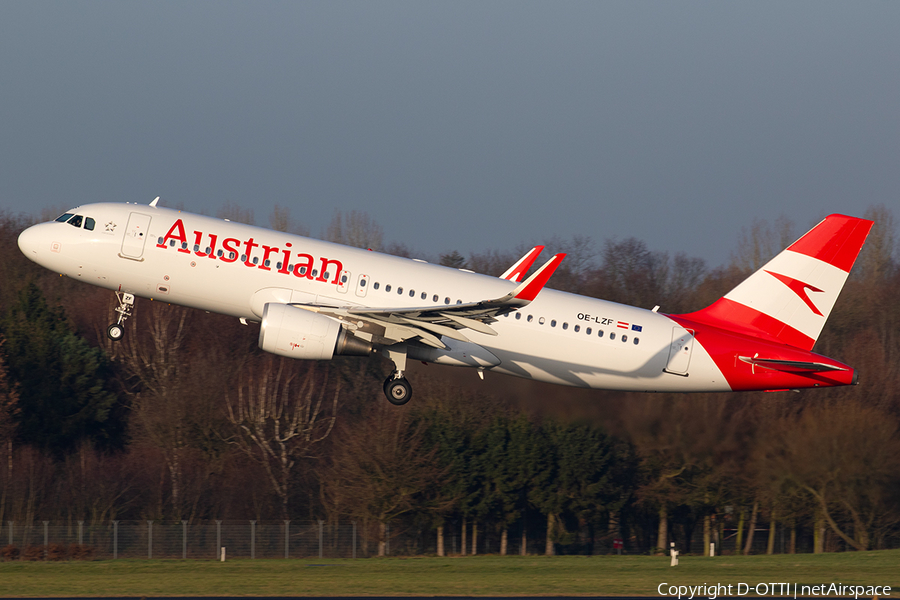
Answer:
225, 355, 341, 519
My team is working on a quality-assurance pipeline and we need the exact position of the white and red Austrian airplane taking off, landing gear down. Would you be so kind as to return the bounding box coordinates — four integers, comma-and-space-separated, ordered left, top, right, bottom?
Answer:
18, 198, 873, 405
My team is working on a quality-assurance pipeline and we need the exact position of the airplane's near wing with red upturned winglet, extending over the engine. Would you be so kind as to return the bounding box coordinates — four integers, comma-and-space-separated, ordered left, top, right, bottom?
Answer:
294, 254, 566, 349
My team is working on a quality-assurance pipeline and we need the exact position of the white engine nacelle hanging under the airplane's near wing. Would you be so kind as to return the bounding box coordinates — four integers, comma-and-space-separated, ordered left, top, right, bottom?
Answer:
259, 302, 373, 360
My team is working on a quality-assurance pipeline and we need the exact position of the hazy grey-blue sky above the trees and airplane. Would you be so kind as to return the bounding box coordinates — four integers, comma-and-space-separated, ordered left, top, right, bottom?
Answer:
0, 0, 900, 266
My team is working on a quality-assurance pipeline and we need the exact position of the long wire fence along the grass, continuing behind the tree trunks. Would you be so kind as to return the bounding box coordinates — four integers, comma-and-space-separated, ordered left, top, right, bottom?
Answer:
0, 520, 811, 560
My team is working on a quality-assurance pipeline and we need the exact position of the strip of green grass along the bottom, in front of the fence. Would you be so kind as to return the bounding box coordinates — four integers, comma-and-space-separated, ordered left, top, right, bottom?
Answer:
0, 550, 900, 598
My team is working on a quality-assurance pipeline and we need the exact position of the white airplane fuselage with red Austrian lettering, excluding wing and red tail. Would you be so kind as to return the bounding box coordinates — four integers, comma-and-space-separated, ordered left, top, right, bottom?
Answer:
19, 203, 731, 391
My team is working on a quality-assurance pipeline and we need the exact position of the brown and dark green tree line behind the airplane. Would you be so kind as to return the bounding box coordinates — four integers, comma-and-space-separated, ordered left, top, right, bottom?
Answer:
0, 206, 900, 554
